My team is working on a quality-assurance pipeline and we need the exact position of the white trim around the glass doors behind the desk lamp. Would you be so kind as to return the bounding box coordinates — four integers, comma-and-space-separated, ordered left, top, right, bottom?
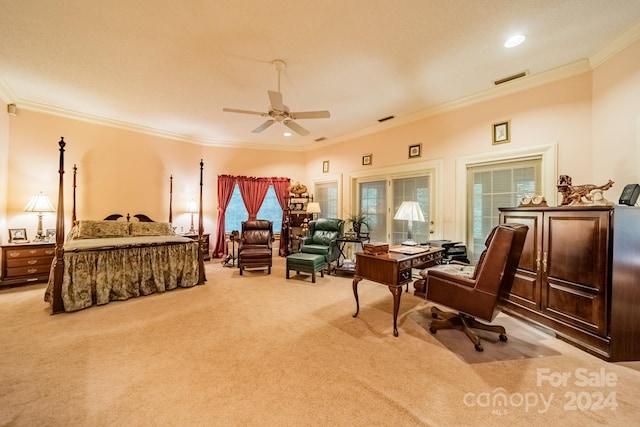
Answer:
349, 159, 444, 240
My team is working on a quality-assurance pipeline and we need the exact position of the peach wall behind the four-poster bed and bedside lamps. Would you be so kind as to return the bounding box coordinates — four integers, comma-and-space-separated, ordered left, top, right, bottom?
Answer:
2, 110, 304, 241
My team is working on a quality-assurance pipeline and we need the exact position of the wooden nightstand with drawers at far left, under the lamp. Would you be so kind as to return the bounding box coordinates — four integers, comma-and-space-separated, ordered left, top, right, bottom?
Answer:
0, 243, 56, 286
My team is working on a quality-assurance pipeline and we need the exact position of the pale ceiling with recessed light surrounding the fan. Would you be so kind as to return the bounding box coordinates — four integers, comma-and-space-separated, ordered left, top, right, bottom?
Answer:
0, 0, 640, 149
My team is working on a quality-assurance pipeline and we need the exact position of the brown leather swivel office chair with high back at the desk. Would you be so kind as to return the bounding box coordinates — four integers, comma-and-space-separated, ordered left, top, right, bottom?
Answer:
414, 224, 529, 351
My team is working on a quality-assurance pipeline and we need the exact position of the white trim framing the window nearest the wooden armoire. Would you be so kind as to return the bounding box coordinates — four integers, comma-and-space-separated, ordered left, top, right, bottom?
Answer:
455, 144, 558, 244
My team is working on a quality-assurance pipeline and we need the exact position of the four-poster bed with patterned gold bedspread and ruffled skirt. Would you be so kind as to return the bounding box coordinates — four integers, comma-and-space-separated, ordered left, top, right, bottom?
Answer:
45, 138, 206, 314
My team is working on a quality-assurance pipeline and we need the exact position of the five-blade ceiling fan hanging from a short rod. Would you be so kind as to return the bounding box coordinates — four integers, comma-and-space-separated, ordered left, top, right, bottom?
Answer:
222, 59, 331, 136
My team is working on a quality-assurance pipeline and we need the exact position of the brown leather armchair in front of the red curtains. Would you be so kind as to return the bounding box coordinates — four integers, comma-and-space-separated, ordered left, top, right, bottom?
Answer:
238, 219, 275, 276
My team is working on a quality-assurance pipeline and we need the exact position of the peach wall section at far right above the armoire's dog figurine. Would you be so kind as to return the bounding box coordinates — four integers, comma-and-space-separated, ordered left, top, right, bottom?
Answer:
592, 41, 640, 186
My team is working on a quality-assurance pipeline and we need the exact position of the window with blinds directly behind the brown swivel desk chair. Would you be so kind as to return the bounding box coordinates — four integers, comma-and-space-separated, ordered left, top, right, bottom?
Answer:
467, 158, 542, 260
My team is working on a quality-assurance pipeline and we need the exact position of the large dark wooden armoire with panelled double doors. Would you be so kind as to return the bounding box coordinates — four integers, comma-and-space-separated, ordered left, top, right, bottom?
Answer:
500, 206, 640, 361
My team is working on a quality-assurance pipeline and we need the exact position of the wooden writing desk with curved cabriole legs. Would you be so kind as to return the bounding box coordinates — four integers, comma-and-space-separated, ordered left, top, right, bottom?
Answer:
353, 246, 444, 337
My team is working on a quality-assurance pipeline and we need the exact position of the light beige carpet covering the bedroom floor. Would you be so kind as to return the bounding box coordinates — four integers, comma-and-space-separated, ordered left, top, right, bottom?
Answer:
0, 257, 640, 426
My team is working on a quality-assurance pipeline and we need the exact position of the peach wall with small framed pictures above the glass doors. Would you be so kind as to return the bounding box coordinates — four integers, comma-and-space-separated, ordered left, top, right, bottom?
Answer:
307, 73, 593, 238
